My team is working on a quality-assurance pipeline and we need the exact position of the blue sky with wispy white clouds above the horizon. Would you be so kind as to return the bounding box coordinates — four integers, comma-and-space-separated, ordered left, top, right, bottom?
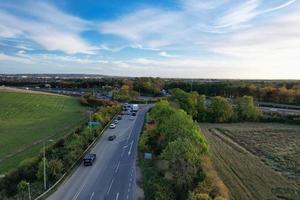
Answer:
0, 0, 300, 79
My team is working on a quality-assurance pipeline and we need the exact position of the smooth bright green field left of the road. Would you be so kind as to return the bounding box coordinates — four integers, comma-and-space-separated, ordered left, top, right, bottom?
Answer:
0, 90, 85, 174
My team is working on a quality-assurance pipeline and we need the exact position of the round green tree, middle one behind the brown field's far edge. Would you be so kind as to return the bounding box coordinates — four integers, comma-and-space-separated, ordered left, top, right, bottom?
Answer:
209, 96, 234, 123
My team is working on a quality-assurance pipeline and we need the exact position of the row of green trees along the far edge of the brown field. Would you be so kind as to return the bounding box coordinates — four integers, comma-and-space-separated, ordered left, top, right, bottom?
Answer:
169, 88, 262, 123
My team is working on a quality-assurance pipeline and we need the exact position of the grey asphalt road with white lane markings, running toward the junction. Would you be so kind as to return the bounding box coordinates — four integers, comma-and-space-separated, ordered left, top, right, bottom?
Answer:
48, 106, 149, 200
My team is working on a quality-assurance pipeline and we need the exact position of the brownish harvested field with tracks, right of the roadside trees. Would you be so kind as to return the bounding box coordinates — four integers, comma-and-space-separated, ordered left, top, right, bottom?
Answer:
201, 123, 300, 200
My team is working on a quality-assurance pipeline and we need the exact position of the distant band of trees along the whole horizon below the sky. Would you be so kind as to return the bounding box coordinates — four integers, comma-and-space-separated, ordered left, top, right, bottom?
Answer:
0, 77, 300, 105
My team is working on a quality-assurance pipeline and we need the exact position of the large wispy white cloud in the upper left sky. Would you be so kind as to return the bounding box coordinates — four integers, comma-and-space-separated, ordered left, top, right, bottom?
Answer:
0, 2, 95, 53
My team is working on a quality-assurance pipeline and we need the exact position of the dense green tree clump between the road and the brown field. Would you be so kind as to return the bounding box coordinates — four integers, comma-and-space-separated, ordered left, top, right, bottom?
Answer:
139, 101, 227, 200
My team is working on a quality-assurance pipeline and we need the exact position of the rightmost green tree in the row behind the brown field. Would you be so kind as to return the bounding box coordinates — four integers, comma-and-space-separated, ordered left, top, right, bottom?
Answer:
237, 96, 261, 121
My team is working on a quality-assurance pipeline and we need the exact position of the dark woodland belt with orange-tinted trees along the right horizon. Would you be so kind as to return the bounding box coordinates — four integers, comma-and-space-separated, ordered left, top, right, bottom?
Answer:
166, 81, 300, 105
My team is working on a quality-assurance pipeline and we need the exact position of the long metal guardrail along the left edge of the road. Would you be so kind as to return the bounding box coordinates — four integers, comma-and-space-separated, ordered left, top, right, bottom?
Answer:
34, 113, 119, 200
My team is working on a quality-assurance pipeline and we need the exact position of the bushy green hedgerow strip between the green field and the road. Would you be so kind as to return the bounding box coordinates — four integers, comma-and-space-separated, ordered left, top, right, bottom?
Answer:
0, 91, 121, 199
